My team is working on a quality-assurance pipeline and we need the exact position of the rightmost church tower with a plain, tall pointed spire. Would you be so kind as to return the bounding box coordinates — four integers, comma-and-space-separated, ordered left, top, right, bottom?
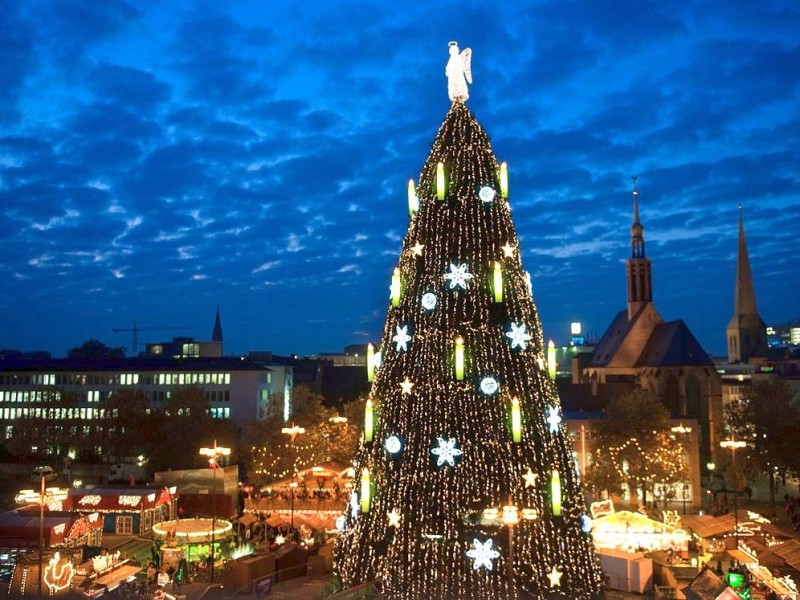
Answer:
728, 205, 767, 363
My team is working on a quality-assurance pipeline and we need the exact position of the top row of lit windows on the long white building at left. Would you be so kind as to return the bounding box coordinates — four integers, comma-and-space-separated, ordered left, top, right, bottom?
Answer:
0, 373, 231, 386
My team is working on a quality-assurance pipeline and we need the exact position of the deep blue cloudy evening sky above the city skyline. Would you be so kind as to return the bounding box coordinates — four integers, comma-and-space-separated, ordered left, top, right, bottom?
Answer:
0, 0, 800, 355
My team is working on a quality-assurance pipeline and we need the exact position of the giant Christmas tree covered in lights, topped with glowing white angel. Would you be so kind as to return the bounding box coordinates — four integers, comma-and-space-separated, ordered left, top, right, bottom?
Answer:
334, 47, 601, 600
